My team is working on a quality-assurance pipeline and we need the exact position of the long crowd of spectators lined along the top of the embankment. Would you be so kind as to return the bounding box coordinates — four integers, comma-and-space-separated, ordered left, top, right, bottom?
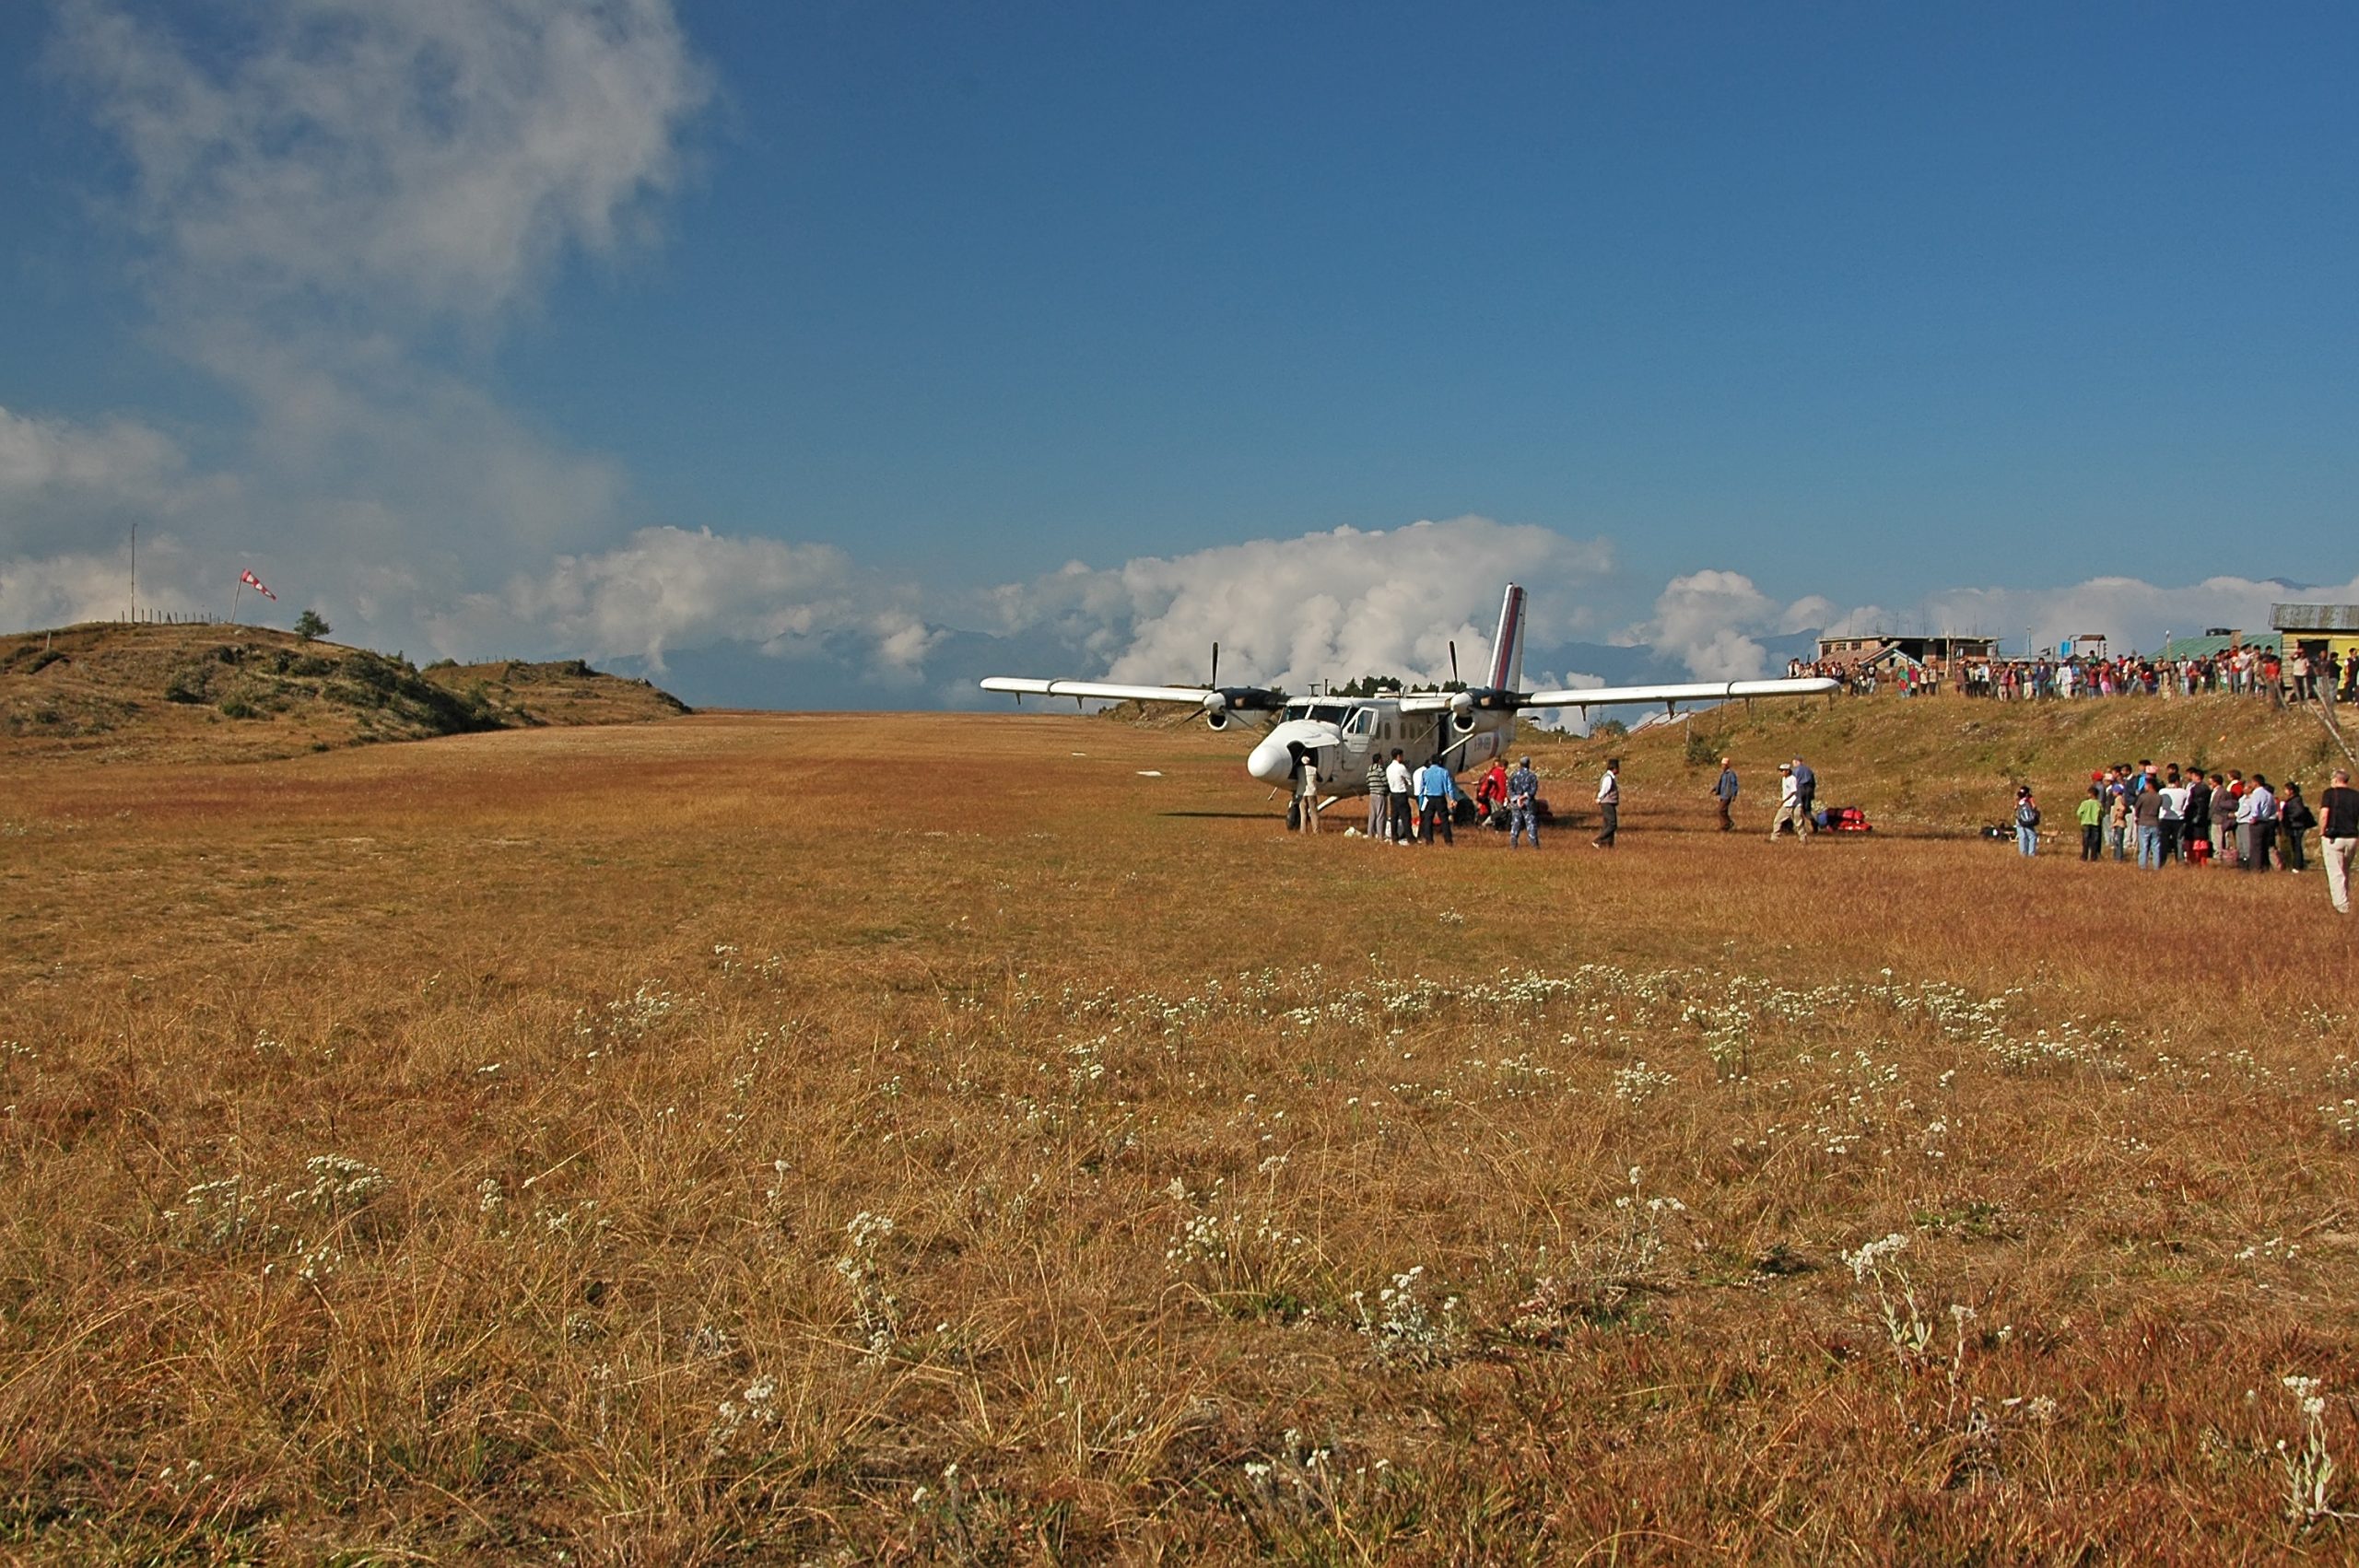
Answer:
1786, 646, 2359, 703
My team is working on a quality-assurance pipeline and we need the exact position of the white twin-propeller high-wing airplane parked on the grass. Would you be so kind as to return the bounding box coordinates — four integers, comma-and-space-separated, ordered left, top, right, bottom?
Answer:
984, 582, 1837, 800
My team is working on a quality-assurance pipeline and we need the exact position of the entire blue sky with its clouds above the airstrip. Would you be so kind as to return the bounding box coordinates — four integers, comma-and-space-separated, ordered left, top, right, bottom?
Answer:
0, 0, 2359, 705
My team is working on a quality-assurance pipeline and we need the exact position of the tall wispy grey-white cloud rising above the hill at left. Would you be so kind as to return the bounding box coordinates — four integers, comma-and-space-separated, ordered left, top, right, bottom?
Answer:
0, 0, 710, 644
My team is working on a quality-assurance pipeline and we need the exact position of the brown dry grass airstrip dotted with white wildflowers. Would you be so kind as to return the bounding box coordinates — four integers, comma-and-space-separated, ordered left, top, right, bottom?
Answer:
0, 698, 2359, 1563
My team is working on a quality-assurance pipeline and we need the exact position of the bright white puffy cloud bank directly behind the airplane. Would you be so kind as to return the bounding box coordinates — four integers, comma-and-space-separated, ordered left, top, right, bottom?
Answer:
991, 517, 1611, 691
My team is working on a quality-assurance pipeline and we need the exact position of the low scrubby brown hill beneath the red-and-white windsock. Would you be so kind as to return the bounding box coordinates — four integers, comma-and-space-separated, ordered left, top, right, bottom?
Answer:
0, 623, 689, 759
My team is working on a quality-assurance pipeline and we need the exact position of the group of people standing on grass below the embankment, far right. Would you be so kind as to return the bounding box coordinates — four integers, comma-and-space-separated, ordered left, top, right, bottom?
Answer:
2014, 762, 2359, 915
